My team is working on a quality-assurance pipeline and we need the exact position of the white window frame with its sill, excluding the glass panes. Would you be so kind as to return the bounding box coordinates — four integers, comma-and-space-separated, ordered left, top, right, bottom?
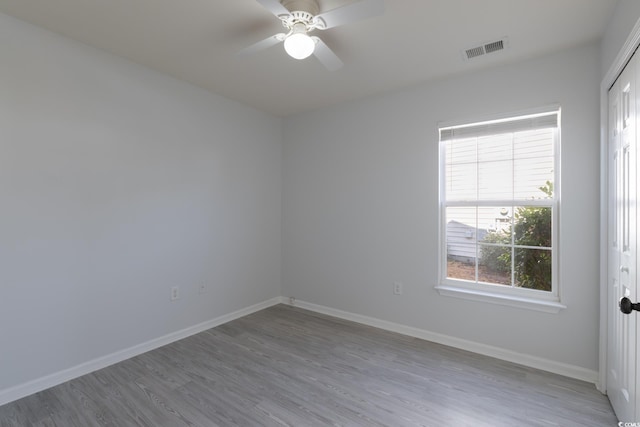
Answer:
435, 105, 566, 313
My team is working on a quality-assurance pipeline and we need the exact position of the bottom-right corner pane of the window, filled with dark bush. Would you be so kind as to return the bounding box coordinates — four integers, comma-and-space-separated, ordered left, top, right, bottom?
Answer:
514, 248, 552, 291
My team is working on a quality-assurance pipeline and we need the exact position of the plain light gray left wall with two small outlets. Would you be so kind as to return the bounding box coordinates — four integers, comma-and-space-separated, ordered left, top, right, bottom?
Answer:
0, 15, 282, 390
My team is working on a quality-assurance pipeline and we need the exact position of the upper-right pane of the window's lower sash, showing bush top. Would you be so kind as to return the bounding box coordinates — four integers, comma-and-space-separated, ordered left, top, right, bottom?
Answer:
513, 206, 551, 248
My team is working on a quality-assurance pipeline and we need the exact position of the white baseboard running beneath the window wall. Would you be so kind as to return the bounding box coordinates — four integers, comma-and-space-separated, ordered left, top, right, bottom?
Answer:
282, 298, 599, 385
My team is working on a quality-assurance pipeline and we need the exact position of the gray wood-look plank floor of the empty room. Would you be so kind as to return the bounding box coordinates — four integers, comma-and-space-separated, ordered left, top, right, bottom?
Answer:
0, 305, 617, 427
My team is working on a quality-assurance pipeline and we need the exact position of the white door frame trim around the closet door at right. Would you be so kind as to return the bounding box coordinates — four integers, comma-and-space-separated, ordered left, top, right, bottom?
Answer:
596, 19, 640, 393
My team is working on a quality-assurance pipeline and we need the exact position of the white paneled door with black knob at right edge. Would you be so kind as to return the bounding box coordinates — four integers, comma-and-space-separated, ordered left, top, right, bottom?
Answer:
607, 51, 640, 422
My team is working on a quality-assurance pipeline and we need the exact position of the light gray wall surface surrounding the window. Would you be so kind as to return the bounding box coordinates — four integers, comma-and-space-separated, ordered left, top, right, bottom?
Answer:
283, 45, 600, 370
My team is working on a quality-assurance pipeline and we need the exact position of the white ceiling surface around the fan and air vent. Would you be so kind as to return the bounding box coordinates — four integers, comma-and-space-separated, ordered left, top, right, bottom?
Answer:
0, 0, 618, 116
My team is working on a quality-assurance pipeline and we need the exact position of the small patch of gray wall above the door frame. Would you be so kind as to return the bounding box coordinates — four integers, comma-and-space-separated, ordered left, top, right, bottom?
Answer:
601, 0, 640, 76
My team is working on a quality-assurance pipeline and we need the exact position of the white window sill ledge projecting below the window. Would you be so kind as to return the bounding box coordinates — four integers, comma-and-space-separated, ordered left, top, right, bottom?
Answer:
436, 285, 567, 314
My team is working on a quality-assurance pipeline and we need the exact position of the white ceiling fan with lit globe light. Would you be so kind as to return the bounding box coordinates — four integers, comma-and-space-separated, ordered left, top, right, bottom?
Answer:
238, 0, 384, 71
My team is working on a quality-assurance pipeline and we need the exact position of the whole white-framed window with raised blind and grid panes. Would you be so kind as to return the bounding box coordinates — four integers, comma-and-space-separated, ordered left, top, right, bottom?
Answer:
438, 109, 561, 309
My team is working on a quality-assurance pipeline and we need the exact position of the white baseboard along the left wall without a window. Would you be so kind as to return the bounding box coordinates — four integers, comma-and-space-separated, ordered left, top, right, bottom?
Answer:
0, 297, 282, 405
